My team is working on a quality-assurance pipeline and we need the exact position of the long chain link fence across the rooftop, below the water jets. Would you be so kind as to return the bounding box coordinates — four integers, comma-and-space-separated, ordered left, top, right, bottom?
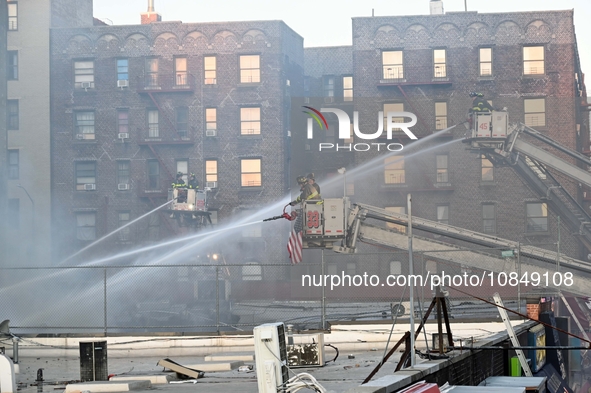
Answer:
0, 248, 567, 334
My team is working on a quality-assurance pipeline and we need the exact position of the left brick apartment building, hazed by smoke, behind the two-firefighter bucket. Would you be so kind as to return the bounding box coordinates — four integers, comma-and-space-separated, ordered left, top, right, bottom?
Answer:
51, 12, 303, 263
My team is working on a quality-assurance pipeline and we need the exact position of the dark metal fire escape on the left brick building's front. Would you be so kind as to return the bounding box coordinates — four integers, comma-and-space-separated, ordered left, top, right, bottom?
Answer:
137, 73, 195, 233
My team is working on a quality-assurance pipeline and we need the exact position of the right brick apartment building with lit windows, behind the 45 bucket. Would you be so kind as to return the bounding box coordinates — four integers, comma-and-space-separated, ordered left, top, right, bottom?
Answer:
293, 2, 589, 288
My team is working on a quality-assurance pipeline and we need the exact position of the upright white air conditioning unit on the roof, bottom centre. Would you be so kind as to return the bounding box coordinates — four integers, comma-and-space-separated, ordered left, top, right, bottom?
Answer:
253, 322, 289, 393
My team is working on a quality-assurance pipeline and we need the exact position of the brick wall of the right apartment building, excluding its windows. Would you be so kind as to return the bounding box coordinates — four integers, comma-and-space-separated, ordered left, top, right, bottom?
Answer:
303, 11, 589, 257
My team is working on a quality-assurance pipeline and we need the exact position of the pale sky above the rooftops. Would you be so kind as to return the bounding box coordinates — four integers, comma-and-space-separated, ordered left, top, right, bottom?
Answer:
94, 0, 591, 87
